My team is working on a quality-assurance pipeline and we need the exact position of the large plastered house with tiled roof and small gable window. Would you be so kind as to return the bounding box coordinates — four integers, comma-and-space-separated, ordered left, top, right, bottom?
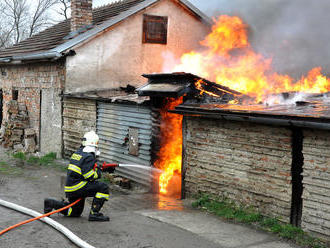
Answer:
0, 0, 210, 157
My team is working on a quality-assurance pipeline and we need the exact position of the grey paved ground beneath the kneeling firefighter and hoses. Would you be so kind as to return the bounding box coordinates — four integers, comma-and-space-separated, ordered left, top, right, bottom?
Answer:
0, 148, 296, 248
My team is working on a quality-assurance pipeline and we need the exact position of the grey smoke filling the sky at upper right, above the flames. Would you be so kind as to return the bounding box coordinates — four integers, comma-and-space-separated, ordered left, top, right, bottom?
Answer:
190, 0, 330, 78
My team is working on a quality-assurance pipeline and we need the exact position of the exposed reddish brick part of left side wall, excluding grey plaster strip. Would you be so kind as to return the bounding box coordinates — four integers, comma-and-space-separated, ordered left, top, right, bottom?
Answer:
0, 62, 65, 152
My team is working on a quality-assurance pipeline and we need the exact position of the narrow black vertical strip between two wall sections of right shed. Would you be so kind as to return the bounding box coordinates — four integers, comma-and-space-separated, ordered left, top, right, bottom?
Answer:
290, 127, 304, 226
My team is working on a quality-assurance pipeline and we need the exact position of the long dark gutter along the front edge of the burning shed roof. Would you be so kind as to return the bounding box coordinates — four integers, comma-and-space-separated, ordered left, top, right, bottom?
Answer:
169, 108, 330, 130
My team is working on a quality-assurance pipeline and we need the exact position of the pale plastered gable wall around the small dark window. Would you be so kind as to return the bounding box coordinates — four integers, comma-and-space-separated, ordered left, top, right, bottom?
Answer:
65, 0, 208, 92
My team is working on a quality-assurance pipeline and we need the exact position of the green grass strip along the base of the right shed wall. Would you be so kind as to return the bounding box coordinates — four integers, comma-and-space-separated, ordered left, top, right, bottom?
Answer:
192, 194, 328, 248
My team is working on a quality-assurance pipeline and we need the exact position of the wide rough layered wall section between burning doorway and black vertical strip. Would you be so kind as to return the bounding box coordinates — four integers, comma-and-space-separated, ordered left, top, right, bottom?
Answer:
184, 117, 292, 223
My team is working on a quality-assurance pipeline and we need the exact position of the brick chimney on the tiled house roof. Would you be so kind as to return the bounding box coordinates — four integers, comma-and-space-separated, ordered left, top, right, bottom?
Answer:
71, 0, 93, 32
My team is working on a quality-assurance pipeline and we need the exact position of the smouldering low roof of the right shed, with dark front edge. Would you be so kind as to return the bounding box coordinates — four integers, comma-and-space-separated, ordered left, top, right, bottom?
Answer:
174, 93, 330, 130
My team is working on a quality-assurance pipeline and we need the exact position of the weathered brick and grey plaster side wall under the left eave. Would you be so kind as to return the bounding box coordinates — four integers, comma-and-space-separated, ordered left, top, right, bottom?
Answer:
0, 61, 65, 154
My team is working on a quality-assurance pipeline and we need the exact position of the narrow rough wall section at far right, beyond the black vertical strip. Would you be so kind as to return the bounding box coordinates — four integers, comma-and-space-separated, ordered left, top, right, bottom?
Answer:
301, 130, 330, 240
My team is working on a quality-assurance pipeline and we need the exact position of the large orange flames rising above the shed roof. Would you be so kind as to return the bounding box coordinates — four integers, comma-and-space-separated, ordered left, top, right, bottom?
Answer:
172, 15, 330, 103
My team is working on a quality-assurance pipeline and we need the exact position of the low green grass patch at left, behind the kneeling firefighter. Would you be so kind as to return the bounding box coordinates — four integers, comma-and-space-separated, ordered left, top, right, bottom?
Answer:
12, 152, 66, 171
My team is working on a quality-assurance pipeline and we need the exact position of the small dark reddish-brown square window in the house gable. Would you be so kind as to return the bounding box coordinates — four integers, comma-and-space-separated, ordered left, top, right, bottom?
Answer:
143, 15, 167, 44
